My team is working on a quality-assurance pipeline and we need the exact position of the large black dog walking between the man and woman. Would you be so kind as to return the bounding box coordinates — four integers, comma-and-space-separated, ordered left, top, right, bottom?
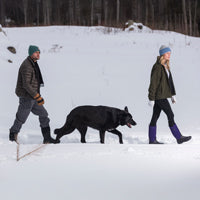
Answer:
54, 106, 136, 144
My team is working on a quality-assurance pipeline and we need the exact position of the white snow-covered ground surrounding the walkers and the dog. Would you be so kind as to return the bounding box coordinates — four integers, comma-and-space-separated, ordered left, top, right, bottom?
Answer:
0, 26, 200, 200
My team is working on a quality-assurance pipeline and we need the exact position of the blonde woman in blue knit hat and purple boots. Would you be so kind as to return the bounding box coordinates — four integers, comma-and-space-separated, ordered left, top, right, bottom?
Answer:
149, 45, 192, 144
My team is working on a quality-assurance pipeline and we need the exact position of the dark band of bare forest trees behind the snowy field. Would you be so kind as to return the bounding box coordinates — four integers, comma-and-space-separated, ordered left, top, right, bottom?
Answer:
0, 0, 200, 36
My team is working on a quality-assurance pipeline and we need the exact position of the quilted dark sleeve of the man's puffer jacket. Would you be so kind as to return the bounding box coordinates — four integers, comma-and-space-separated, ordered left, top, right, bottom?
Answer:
21, 65, 38, 97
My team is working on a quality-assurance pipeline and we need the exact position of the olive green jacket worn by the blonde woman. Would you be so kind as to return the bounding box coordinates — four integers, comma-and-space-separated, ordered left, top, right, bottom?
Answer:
148, 57, 176, 101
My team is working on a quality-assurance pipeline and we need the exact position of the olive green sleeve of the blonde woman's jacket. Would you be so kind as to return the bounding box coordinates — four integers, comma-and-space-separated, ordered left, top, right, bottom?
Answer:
148, 65, 162, 101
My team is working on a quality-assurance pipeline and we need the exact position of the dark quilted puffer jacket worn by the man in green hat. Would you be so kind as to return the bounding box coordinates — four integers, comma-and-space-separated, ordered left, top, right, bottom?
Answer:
15, 57, 43, 98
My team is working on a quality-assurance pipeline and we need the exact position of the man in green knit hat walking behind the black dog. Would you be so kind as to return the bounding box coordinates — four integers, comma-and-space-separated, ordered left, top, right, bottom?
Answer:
9, 45, 56, 144
